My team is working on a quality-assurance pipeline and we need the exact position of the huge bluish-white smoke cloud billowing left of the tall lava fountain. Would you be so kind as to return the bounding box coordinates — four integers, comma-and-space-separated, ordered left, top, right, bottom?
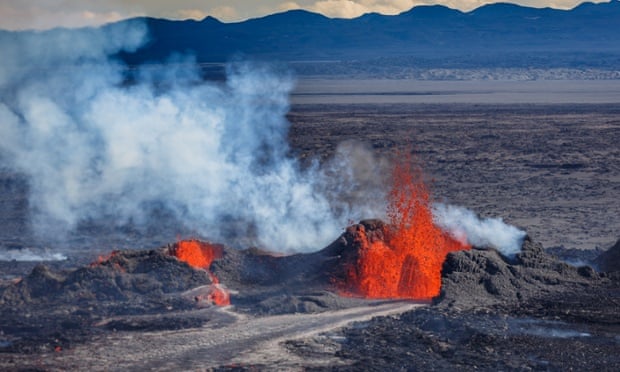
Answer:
0, 24, 384, 251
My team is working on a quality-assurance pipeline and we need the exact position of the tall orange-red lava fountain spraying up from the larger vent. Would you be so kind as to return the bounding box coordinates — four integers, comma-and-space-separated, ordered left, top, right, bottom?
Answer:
345, 159, 470, 299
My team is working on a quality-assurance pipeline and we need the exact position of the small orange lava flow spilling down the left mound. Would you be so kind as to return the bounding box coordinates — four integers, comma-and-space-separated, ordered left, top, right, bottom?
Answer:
174, 240, 230, 306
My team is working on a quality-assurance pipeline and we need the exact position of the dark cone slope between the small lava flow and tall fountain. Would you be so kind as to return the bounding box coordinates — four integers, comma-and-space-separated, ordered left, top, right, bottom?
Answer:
211, 220, 384, 315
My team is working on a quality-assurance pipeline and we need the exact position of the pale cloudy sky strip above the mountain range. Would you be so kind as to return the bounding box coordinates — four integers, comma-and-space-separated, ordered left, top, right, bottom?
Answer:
0, 0, 612, 30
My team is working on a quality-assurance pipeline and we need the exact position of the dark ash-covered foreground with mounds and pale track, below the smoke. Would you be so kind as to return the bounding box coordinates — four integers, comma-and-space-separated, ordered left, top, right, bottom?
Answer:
0, 221, 620, 370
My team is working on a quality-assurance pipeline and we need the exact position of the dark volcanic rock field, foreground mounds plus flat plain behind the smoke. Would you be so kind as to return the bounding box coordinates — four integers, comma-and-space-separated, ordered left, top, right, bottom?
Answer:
0, 103, 620, 371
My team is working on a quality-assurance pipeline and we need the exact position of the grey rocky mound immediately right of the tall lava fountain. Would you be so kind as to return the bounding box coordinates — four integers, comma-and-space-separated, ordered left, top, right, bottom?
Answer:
435, 237, 601, 308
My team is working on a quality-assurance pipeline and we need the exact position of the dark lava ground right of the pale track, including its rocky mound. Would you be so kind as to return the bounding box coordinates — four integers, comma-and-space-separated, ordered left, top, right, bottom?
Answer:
338, 238, 620, 371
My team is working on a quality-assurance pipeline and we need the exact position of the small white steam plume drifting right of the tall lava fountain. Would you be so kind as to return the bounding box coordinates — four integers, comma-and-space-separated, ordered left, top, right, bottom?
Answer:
433, 203, 526, 257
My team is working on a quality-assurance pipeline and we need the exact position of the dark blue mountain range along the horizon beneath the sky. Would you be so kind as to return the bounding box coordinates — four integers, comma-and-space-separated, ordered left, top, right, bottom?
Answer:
111, 0, 620, 67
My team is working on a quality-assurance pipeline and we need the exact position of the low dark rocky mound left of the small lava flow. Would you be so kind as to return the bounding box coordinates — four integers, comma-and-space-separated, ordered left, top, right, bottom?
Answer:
0, 249, 211, 313
